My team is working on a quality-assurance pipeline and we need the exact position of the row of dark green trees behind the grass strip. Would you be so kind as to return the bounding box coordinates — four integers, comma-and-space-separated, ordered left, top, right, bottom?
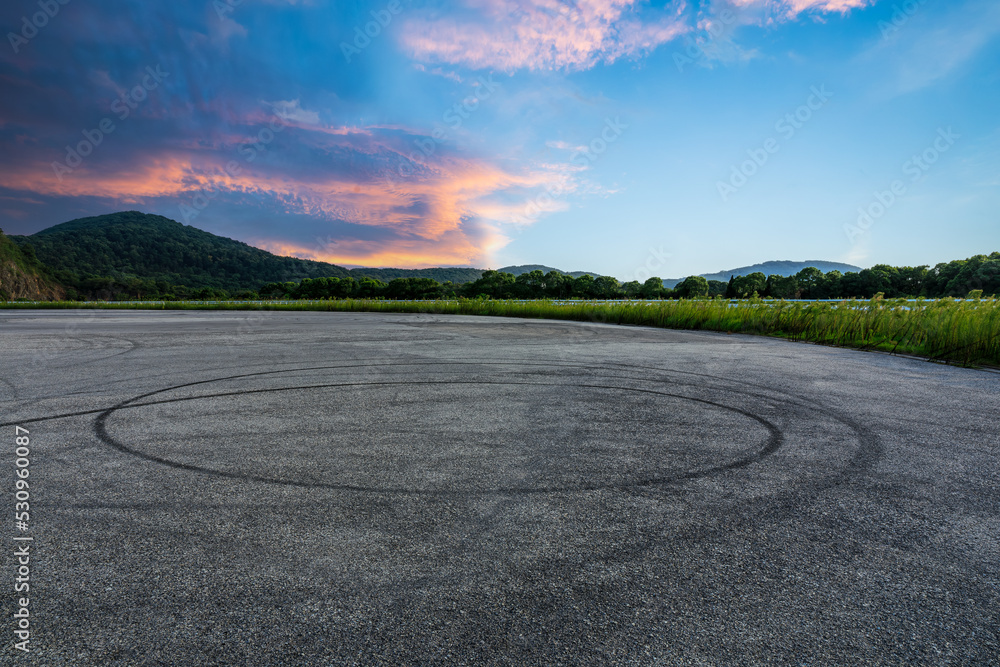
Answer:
28, 249, 1000, 301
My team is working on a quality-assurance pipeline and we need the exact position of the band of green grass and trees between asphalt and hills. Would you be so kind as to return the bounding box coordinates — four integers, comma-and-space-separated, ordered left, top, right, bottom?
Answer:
0, 243, 1000, 366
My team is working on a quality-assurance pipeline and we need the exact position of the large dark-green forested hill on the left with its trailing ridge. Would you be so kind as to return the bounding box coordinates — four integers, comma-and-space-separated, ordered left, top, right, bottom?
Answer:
11, 211, 492, 291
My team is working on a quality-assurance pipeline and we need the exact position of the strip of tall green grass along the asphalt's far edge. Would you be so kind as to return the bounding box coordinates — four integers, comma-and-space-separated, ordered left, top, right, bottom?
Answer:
7, 299, 1000, 366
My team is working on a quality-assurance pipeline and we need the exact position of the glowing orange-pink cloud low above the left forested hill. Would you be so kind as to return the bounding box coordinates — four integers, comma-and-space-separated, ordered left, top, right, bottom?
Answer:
0, 125, 554, 267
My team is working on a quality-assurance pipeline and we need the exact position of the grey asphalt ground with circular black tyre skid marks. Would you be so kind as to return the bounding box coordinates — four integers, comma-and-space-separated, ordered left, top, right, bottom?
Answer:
0, 311, 1000, 665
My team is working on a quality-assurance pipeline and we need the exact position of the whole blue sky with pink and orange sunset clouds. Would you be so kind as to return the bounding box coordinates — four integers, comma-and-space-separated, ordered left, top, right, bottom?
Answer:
0, 0, 1000, 280
